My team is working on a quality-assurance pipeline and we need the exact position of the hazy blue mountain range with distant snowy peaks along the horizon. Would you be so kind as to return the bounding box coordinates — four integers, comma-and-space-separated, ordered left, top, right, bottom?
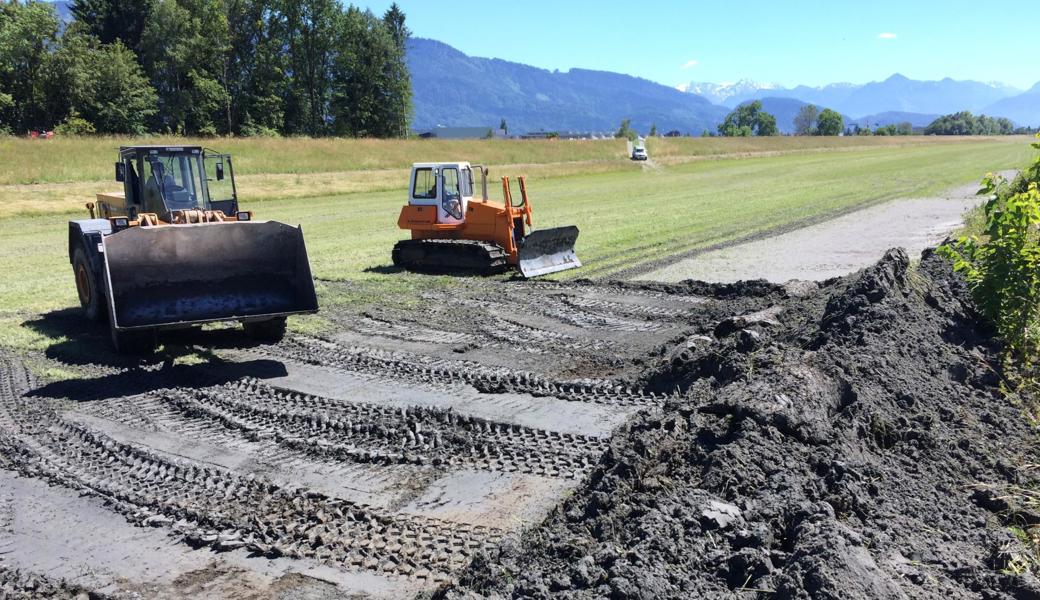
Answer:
408, 37, 1040, 134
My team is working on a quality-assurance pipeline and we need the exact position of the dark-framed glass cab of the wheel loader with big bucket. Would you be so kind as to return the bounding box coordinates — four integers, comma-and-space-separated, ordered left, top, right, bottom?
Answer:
115, 146, 238, 221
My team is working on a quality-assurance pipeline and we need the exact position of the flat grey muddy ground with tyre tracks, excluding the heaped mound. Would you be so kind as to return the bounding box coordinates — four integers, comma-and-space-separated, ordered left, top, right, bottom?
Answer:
0, 280, 773, 598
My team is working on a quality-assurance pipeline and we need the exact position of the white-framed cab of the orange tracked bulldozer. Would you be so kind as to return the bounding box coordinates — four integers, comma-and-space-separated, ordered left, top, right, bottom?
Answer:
408, 162, 487, 224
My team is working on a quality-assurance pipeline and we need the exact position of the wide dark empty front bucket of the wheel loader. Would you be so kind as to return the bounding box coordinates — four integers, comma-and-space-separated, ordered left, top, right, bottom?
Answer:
103, 221, 317, 331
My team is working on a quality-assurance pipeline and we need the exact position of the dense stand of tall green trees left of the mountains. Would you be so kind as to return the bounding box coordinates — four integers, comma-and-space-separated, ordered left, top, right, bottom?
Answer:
0, 0, 412, 137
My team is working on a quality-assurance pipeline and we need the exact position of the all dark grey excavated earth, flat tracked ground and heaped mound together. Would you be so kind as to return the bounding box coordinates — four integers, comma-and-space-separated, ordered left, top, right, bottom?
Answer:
0, 251, 1040, 598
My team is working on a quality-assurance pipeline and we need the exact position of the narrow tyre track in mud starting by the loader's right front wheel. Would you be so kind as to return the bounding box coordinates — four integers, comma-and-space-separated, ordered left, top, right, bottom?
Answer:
263, 337, 668, 406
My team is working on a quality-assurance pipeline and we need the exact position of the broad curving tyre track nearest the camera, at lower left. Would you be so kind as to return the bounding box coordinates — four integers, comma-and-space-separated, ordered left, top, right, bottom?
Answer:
1, 420, 503, 579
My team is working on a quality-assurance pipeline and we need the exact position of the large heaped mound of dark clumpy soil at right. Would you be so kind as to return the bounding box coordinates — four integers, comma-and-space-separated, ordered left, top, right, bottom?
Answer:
441, 251, 1040, 599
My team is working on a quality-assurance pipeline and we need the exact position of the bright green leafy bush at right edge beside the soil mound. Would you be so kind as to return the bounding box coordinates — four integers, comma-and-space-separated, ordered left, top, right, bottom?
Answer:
939, 136, 1040, 359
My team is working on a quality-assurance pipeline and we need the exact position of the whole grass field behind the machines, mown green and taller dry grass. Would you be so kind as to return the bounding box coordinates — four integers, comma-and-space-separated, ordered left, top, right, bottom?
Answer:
0, 137, 1031, 355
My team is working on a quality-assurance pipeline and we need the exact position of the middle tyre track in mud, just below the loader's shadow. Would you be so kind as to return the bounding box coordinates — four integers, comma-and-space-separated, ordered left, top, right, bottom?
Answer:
151, 380, 606, 478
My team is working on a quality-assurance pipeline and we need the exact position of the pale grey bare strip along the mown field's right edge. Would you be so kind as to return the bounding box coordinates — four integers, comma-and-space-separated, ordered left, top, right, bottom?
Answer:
634, 172, 1013, 283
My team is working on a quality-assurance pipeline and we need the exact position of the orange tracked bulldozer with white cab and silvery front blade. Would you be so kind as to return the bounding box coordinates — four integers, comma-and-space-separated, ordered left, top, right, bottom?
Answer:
391, 162, 581, 278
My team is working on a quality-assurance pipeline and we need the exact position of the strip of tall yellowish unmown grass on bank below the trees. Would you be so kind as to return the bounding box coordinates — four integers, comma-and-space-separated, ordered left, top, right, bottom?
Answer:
0, 135, 1006, 185
